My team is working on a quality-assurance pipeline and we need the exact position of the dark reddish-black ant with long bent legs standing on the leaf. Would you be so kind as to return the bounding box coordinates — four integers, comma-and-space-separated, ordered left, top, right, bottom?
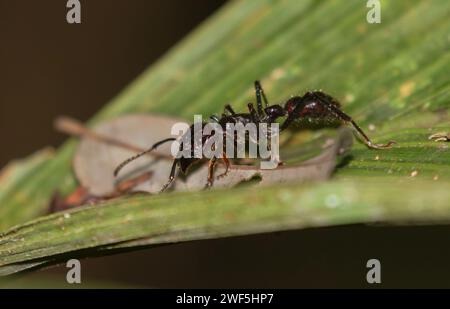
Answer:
114, 81, 395, 192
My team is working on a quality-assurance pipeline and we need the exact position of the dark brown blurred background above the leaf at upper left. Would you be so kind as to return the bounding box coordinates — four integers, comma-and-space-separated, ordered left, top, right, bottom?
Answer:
0, 0, 225, 167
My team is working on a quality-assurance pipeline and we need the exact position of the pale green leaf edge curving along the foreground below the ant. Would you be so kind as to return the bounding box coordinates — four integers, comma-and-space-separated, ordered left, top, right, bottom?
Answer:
0, 178, 450, 270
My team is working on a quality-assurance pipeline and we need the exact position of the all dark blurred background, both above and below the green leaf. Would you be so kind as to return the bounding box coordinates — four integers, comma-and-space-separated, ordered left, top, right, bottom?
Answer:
0, 0, 450, 287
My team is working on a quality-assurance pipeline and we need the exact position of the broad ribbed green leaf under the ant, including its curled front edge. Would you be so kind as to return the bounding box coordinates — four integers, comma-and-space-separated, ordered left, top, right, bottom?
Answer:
0, 0, 450, 274
